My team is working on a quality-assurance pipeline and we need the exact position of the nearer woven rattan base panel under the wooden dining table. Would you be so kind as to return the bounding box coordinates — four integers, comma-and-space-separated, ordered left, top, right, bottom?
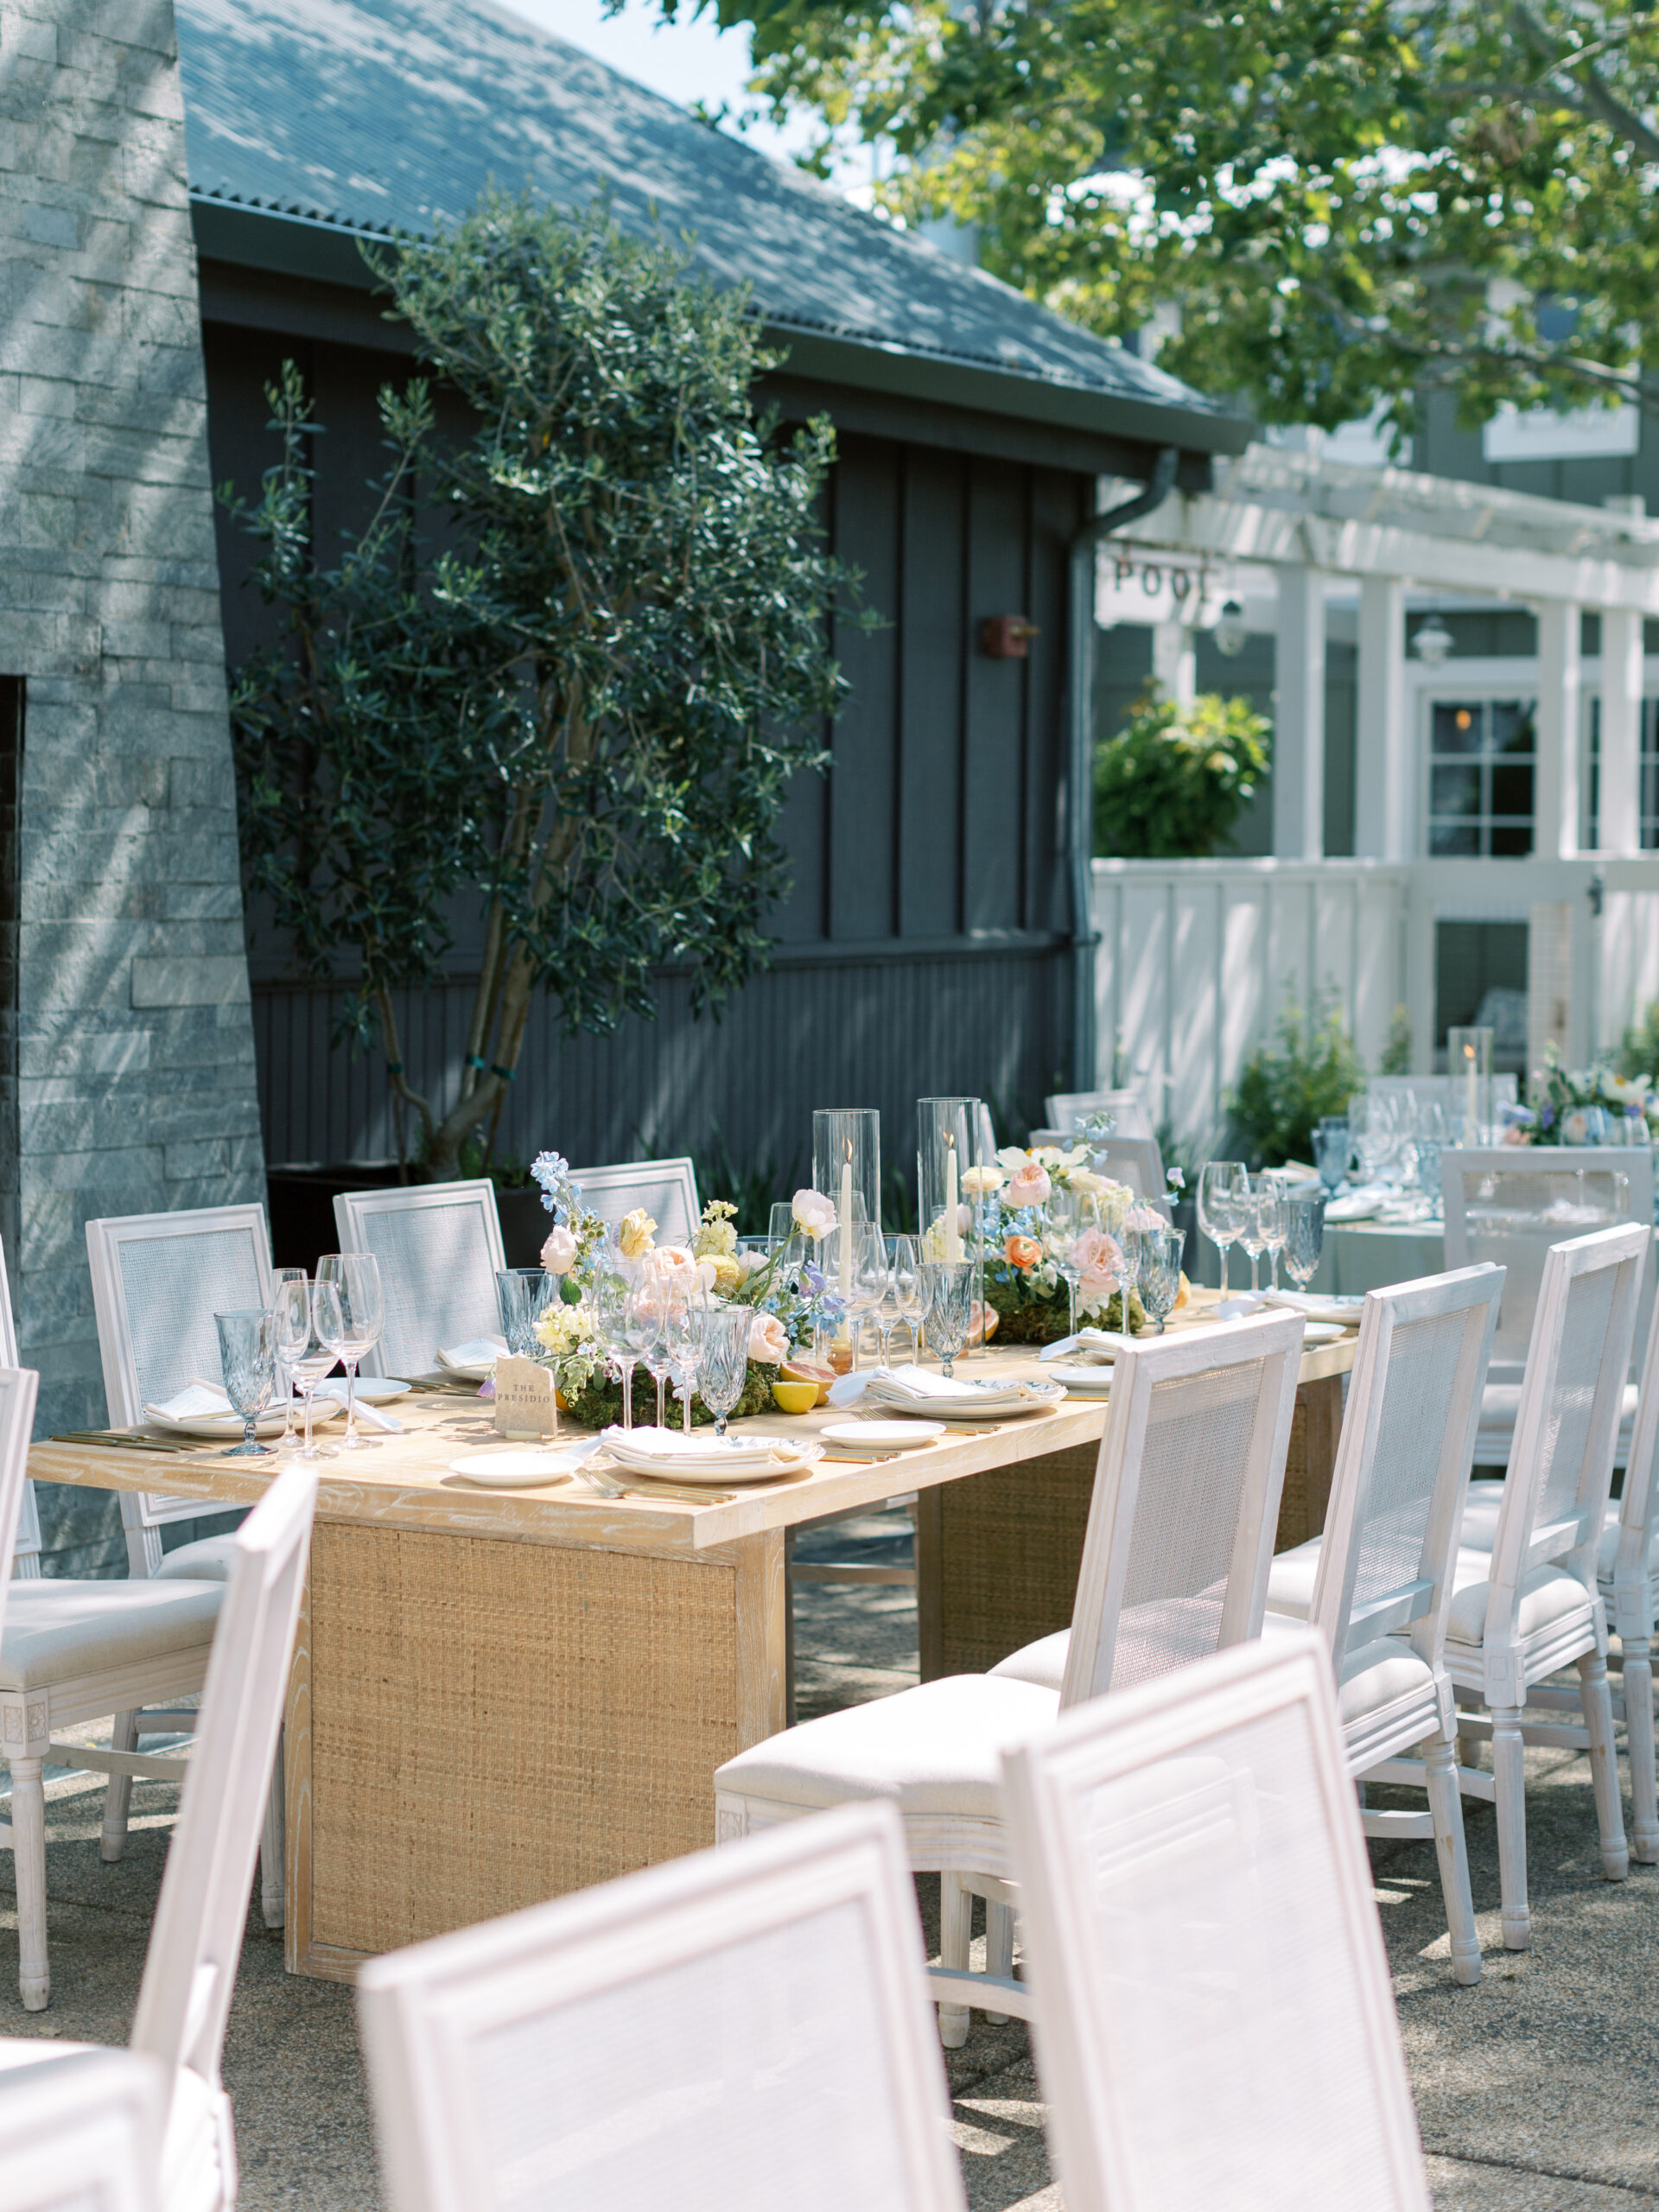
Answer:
288, 1522, 783, 1975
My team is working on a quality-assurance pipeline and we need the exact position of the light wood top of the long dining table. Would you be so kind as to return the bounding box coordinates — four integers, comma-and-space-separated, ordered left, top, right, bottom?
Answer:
29, 1289, 1356, 1553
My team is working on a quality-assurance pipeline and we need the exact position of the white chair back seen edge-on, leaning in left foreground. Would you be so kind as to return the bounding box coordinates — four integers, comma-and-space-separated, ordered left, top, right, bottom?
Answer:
130, 1466, 316, 2090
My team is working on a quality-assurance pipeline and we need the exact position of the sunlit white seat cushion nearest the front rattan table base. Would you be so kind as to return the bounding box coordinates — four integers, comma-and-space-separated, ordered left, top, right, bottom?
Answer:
715, 1675, 1059, 1821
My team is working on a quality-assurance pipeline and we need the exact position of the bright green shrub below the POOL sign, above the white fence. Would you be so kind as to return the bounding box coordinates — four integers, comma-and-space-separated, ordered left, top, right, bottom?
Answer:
1095, 692, 1272, 861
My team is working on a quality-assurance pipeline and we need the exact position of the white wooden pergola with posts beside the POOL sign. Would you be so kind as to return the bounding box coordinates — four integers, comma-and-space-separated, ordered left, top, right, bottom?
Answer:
1097, 445, 1659, 861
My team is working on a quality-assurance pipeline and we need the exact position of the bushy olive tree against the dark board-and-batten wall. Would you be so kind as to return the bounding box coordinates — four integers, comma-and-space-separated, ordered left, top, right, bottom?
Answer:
224, 194, 852, 1174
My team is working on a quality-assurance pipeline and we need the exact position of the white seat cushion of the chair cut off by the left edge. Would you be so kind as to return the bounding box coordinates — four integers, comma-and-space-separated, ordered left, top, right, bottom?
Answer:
0, 1580, 226, 1690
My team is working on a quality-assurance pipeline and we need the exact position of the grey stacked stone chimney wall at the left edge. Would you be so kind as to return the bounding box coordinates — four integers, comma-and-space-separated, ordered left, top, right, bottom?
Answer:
0, 0, 265, 1571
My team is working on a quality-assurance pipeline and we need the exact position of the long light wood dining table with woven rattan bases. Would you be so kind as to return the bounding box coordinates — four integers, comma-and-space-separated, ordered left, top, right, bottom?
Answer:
29, 1292, 1354, 1980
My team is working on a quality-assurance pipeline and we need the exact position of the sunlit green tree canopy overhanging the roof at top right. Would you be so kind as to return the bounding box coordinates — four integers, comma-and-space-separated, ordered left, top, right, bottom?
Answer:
657, 0, 1659, 434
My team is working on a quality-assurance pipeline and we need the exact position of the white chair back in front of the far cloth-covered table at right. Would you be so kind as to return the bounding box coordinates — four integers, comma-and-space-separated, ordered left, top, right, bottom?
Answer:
1440, 1144, 1652, 1382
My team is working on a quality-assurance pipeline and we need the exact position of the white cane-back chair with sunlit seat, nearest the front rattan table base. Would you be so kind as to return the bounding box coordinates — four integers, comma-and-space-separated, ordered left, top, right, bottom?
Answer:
715, 1314, 1303, 2044
